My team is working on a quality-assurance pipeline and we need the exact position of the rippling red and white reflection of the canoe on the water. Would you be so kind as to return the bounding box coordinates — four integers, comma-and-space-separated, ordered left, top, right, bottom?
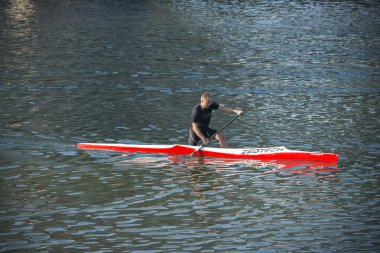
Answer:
119, 155, 338, 177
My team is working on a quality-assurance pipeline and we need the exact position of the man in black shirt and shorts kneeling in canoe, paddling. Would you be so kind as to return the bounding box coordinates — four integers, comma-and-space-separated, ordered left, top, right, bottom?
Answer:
189, 92, 243, 148
